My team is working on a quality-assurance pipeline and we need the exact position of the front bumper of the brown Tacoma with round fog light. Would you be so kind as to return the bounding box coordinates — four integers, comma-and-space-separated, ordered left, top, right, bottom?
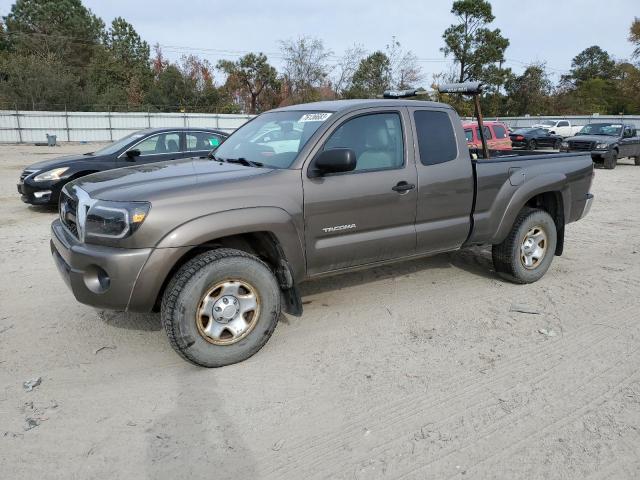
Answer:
51, 220, 155, 310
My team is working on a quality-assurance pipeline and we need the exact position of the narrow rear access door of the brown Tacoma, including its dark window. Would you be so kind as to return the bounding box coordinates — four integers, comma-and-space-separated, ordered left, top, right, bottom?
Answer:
409, 107, 474, 253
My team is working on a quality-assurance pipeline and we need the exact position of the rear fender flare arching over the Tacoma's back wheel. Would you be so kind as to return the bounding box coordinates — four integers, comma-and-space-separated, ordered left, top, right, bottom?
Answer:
489, 172, 571, 244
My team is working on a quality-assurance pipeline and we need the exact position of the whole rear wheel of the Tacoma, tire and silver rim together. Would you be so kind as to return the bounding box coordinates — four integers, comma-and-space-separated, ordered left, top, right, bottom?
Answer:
491, 208, 558, 283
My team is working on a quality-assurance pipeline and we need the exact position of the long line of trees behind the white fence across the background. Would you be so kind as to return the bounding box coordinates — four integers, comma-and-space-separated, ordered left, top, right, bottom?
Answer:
0, 0, 640, 116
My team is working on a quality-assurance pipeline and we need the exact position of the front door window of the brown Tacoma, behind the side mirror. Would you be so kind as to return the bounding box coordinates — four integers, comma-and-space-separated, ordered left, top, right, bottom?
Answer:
324, 113, 404, 171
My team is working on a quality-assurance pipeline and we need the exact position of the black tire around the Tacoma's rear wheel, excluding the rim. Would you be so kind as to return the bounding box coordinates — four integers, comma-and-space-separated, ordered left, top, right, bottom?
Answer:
491, 207, 558, 284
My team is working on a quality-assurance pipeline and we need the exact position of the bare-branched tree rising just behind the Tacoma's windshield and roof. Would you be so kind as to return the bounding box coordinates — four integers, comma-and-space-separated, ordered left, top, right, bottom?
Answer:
280, 36, 333, 102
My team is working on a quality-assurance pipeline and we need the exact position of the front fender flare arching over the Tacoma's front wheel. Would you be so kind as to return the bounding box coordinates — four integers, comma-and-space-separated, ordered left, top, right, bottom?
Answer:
127, 207, 306, 312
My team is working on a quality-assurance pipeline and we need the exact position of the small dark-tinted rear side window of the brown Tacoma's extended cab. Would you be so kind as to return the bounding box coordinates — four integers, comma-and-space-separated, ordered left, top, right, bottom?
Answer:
413, 110, 458, 165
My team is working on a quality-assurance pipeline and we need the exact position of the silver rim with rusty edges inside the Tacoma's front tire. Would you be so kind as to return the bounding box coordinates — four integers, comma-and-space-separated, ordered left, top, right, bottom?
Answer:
196, 280, 260, 345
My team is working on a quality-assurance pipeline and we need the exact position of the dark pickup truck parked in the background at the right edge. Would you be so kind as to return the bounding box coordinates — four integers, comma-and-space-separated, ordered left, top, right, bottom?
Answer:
560, 122, 640, 170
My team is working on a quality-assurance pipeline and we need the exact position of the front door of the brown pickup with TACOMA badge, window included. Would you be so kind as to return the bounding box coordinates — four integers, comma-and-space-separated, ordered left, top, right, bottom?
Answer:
303, 108, 417, 275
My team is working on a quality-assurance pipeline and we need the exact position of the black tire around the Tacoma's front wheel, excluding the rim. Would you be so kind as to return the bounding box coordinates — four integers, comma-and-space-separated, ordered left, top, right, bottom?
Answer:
161, 248, 281, 367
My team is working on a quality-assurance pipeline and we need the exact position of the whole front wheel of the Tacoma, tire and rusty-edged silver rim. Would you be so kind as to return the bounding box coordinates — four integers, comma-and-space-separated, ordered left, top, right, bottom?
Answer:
161, 248, 281, 367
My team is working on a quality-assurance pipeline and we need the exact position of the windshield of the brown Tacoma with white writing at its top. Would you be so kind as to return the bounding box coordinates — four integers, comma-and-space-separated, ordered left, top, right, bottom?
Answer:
212, 110, 331, 168
